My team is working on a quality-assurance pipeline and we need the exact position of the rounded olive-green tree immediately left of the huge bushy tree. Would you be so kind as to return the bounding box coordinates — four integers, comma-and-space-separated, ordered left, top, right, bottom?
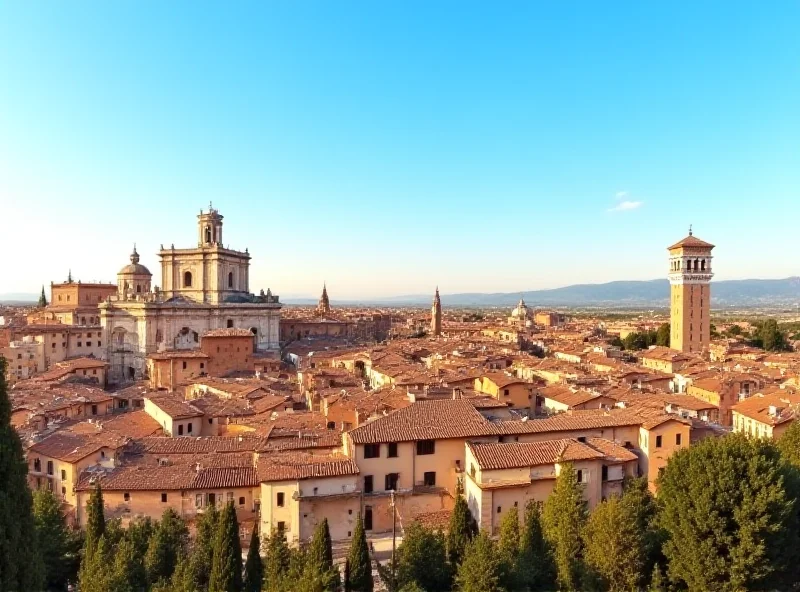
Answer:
583, 496, 644, 592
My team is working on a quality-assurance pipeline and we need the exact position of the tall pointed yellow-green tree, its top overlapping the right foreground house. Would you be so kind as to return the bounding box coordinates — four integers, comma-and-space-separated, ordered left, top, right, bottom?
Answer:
543, 463, 586, 590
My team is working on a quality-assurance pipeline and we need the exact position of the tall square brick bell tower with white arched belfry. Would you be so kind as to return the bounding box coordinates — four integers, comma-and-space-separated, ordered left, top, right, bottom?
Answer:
669, 226, 714, 353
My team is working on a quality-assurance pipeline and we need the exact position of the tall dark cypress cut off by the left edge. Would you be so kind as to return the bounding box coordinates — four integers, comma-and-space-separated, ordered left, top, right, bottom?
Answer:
0, 357, 43, 590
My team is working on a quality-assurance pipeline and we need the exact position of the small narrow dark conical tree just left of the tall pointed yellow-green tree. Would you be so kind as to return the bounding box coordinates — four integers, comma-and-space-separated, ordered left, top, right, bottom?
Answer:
517, 500, 555, 592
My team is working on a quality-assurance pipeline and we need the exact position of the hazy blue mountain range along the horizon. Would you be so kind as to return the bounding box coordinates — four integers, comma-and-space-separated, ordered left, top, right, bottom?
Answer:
6, 277, 800, 307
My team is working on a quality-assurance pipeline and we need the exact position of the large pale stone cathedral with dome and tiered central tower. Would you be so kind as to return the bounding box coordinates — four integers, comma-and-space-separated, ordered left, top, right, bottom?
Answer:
99, 205, 282, 382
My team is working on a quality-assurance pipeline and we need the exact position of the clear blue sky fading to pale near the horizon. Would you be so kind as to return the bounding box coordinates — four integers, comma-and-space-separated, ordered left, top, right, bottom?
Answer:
0, 0, 800, 300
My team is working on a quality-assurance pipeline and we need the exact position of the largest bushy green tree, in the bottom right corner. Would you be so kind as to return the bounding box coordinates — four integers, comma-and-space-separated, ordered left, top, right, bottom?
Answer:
658, 434, 800, 592
